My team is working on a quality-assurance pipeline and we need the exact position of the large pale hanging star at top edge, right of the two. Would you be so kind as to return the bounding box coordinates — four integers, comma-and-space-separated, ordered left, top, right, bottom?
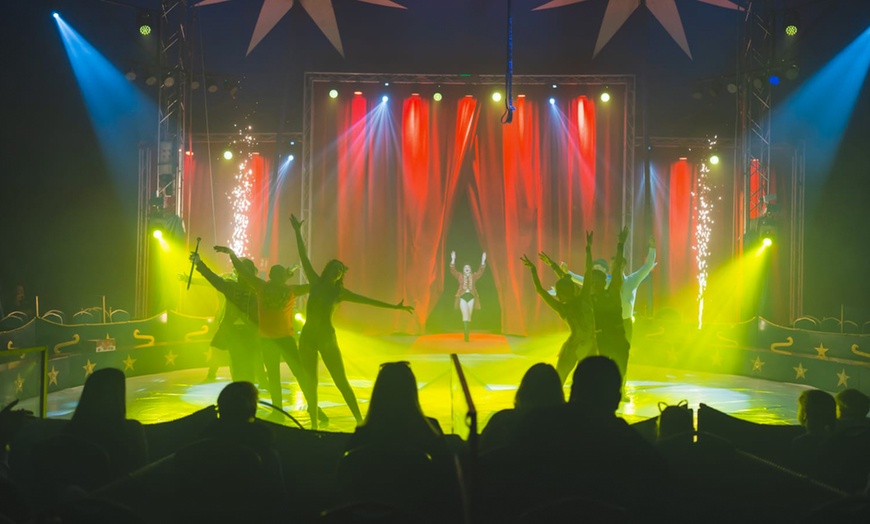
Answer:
532, 0, 742, 58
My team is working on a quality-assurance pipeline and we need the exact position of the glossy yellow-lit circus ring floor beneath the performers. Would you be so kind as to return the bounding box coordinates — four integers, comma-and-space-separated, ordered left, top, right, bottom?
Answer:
32, 332, 807, 437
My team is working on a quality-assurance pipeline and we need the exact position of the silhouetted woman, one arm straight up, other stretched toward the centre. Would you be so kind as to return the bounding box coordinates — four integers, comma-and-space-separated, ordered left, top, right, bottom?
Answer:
290, 215, 414, 429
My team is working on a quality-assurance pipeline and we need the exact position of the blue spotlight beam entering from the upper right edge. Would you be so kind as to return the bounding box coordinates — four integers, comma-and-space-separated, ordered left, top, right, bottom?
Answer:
773, 28, 870, 175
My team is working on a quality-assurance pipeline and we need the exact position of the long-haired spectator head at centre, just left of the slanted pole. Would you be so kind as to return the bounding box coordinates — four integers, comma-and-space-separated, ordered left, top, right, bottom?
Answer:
363, 362, 429, 434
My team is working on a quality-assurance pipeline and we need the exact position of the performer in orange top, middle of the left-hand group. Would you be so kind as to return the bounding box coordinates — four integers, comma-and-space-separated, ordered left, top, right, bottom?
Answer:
214, 246, 328, 426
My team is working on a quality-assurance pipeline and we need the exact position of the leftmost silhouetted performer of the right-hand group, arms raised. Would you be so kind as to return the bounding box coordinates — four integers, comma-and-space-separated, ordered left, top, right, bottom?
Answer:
521, 232, 598, 384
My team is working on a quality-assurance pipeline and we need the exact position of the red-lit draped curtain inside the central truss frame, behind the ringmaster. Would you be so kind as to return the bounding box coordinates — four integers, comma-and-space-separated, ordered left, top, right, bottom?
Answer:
303, 75, 634, 334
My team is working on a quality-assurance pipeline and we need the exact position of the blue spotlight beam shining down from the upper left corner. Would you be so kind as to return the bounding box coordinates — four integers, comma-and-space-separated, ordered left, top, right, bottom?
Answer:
52, 13, 157, 183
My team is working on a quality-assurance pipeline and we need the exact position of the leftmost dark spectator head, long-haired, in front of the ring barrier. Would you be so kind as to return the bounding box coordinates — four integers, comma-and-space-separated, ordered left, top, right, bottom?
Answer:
70, 368, 127, 426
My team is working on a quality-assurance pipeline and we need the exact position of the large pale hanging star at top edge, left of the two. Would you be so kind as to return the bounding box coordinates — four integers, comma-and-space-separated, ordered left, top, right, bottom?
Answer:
196, 0, 407, 56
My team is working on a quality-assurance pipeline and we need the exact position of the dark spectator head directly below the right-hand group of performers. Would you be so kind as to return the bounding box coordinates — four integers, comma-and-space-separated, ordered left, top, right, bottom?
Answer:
568, 356, 622, 414
